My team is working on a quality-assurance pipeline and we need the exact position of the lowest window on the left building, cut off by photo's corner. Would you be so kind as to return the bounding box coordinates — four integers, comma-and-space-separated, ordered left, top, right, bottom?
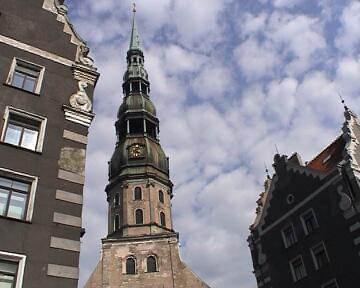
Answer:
0, 252, 26, 288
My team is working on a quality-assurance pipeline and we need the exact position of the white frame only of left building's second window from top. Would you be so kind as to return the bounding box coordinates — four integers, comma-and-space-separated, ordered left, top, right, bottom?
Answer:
1, 106, 47, 152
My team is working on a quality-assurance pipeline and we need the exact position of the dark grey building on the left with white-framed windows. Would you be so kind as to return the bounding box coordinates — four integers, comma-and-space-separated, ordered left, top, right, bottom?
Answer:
0, 0, 99, 288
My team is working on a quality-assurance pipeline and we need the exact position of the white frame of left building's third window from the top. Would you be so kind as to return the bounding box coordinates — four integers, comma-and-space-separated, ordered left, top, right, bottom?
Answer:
0, 168, 38, 222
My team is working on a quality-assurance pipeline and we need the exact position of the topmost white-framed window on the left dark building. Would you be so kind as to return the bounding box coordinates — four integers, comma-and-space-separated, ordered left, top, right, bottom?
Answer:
7, 58, 45, 94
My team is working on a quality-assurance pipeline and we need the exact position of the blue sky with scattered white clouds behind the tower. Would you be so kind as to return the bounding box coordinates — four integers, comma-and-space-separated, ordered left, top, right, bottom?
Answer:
67, 0, 360, 288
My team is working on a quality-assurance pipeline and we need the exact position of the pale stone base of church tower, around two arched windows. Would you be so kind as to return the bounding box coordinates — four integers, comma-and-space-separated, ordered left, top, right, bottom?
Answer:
85, 233, 209, 288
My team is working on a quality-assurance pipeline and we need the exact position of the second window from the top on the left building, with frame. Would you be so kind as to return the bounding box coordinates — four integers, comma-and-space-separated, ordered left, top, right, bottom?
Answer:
1, 107, 46, 152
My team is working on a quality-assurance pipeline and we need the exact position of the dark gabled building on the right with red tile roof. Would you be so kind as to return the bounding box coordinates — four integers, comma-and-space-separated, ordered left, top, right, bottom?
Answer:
248, 106, 360, 288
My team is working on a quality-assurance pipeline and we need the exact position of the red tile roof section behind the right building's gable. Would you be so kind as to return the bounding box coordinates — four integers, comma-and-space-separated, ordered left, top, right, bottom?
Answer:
306, 136, 345, 172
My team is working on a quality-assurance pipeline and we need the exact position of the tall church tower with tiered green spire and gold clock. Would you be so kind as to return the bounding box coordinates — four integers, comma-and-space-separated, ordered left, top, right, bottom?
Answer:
85, 7, 209, 288
